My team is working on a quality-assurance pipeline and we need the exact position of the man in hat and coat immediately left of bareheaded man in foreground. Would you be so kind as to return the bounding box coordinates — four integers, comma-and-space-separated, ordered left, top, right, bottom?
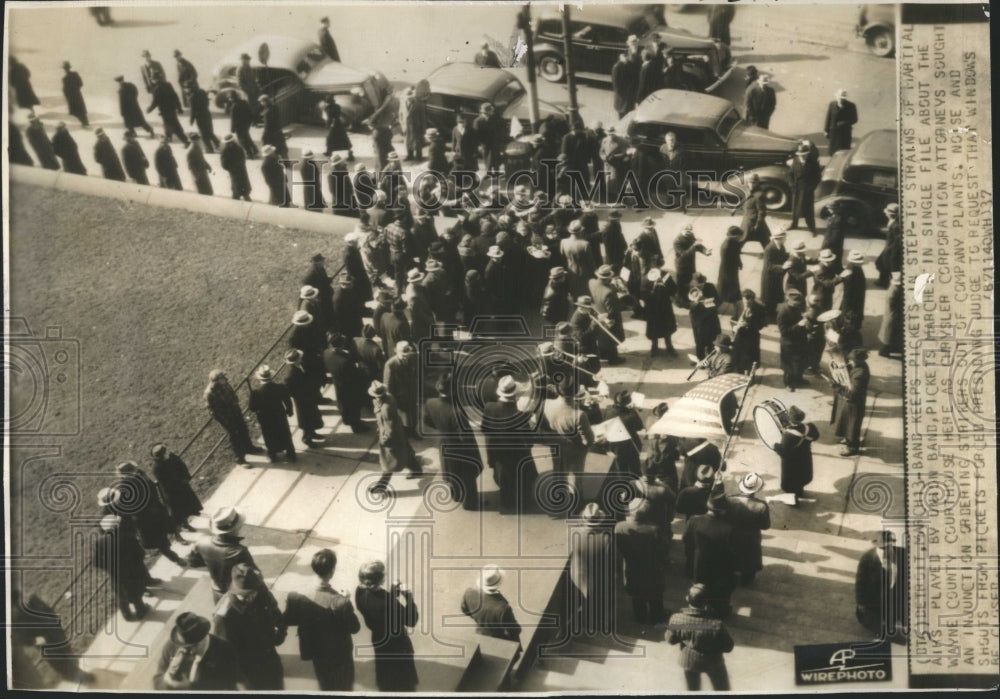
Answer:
212, 563, 288, 691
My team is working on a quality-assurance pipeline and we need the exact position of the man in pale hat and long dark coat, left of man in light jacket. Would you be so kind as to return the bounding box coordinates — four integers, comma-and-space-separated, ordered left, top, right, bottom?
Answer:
482, 375, 538, 514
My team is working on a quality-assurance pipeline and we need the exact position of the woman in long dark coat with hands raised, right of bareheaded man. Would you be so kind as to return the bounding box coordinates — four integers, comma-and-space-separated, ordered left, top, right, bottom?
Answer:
354, 561, 418, 692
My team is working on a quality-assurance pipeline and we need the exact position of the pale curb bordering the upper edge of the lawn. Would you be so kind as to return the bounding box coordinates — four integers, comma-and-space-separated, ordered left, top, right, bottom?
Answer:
10, 165, 357, 235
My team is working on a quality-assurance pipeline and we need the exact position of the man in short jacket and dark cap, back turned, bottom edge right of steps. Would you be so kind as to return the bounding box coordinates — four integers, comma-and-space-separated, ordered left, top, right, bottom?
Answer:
667, 583, 735, 692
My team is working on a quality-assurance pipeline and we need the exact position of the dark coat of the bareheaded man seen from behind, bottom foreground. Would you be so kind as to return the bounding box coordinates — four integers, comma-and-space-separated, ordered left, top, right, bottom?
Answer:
283, 583, 361, 692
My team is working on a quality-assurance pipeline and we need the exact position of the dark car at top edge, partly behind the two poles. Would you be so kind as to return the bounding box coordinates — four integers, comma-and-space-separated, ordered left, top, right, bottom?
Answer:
535, 4, 735, 92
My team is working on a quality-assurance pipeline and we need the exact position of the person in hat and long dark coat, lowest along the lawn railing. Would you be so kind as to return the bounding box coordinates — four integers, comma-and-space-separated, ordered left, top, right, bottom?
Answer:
91, 514, 152, 621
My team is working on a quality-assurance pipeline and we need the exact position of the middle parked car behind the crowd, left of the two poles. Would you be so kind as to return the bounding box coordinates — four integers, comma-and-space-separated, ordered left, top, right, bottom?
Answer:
418, 63, 566, 134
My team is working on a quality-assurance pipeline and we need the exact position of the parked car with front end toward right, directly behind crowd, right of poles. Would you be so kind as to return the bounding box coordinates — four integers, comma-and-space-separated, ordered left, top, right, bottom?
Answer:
617, 90, 799, 211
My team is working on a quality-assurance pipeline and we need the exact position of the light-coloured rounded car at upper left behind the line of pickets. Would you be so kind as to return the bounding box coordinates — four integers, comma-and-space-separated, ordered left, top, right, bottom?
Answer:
209, 36, 388, 128
